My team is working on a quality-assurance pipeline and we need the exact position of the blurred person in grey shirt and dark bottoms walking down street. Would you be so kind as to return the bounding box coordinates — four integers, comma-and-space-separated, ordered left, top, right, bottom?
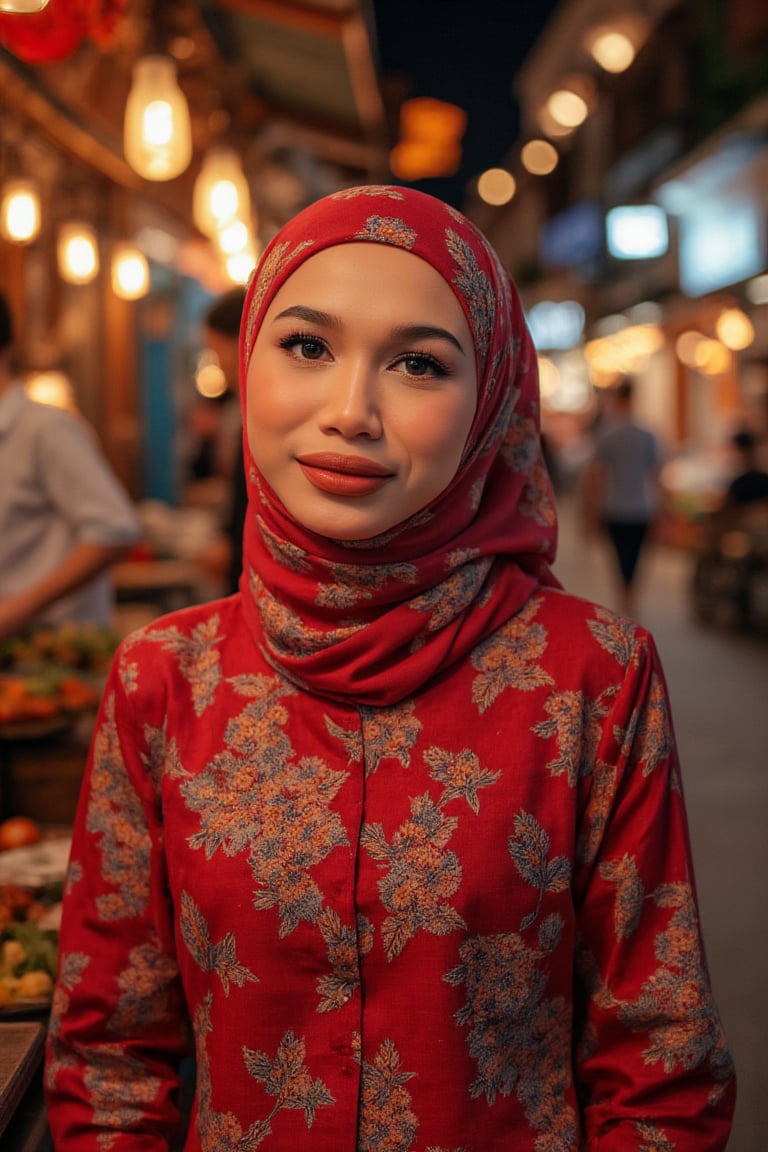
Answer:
585, 376, 662, 616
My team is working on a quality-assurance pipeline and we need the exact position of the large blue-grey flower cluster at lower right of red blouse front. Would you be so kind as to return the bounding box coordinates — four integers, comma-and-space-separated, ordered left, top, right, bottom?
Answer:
443, 916, 576, 1149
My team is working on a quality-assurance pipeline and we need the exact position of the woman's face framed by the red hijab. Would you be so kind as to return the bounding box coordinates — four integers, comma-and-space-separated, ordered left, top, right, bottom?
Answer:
246, 243, 478, 540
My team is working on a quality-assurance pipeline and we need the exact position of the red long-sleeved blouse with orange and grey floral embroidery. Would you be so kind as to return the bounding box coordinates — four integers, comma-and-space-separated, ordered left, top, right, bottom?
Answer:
47, 590, 732, 1152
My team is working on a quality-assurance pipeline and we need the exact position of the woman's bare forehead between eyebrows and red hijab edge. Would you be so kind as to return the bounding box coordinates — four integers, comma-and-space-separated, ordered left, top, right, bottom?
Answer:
265, 243, 469, 332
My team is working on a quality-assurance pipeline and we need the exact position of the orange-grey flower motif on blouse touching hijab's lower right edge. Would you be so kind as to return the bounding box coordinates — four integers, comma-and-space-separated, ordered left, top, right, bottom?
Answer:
472, 598, 553, 713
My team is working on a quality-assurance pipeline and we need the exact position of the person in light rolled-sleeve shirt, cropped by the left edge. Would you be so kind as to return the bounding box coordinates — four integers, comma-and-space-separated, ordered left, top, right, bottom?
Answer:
0, 286, 142, 638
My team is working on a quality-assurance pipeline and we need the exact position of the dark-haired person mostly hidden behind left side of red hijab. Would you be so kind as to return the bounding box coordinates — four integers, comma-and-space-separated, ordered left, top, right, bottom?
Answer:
195, 288, 248, 593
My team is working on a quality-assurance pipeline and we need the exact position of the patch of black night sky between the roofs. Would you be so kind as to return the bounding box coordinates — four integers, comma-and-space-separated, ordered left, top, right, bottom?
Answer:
374, 0, 558, 207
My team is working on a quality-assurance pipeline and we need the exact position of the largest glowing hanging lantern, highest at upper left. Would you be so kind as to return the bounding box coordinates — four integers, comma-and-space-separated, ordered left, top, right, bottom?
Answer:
123, 55, 192, 180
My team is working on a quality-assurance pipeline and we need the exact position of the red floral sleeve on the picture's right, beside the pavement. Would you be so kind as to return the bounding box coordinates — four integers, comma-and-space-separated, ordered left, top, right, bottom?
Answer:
575, 632, 735, 1152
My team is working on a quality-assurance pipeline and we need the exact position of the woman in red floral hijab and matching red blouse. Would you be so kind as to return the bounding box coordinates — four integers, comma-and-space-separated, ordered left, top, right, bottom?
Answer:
46, 187, 733, 1152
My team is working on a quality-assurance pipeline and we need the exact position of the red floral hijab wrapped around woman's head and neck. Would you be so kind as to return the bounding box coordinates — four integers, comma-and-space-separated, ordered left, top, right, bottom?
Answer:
241, 185, 557, 705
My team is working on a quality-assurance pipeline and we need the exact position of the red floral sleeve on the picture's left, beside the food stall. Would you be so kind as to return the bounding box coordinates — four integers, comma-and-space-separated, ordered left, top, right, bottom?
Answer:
46, 664, 187, 1152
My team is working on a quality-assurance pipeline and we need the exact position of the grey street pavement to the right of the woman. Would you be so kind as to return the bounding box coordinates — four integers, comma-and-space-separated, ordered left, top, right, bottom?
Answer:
555, 497, 768, 1152
